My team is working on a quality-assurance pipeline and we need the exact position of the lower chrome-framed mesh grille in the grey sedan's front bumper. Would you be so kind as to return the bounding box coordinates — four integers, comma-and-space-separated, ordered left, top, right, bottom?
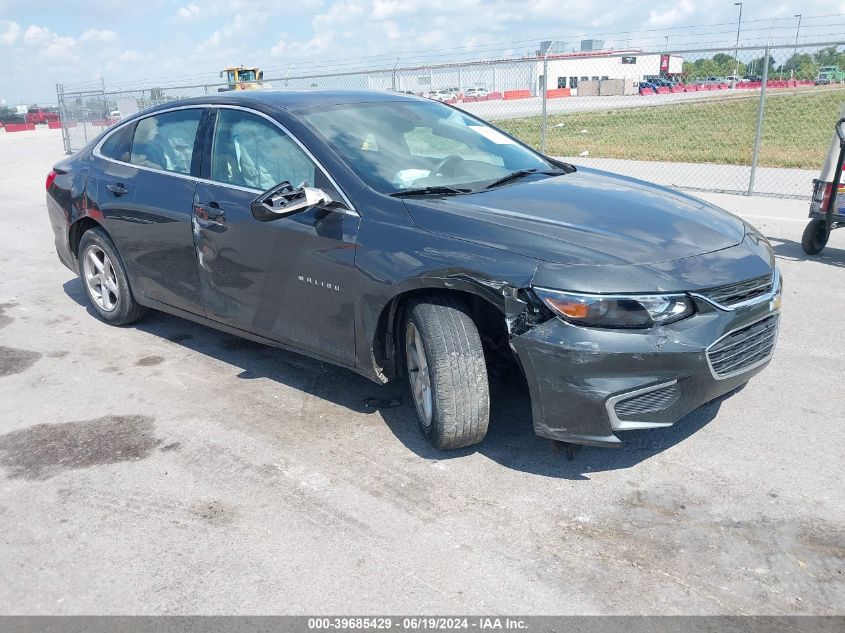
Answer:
707, 314, 778, 379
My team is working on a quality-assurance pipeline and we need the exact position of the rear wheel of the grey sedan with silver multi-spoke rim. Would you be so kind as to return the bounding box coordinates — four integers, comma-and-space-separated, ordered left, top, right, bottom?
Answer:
78, 228, 147, 325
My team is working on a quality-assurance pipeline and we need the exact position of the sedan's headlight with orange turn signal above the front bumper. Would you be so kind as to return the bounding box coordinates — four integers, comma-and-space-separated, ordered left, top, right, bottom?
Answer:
534, 288, 695, 328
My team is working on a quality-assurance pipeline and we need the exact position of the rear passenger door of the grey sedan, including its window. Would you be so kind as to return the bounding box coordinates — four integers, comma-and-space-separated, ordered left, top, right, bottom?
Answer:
92, 108, 204, 315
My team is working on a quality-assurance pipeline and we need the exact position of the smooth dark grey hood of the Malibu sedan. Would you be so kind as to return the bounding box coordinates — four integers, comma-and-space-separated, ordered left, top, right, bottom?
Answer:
405, 168, 745, 266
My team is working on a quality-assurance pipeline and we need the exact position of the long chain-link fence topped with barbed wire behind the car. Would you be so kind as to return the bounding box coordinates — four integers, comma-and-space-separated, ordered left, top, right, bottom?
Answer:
57, 42, 845, 197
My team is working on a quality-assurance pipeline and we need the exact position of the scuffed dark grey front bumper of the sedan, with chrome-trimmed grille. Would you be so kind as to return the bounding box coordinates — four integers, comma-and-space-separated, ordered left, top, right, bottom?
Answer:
511, 276, 781, 446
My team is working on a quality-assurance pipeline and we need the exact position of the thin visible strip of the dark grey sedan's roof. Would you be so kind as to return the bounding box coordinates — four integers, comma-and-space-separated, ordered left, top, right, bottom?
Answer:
145, 88, 427, 113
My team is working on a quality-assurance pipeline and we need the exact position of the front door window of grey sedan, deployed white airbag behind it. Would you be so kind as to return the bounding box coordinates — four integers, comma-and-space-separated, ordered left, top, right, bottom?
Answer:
211, 108, 319, 191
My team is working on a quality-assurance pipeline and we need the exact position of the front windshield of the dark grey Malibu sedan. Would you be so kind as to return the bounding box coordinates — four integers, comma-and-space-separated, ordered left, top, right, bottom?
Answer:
300, 101, 557, 194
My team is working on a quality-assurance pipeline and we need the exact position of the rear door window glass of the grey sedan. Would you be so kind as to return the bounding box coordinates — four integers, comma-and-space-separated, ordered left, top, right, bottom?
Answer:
129, 109, 202, 174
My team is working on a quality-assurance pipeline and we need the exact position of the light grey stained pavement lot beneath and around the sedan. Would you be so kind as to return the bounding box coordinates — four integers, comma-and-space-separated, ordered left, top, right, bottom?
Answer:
0, 130, 845, 614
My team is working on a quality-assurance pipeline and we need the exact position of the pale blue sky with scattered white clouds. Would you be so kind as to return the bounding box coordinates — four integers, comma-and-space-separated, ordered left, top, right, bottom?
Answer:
0, 0, 845, 104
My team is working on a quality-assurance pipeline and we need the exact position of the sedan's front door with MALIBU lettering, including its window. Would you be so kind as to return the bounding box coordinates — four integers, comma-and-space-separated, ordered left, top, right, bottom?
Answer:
193, 108, 359, 365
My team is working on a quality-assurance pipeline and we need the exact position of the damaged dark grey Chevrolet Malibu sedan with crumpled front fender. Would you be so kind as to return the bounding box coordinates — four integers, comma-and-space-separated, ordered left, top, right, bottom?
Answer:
47, 91, 781, 449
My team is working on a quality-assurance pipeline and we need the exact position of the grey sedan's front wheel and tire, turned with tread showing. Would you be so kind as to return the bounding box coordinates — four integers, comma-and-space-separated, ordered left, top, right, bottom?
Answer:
400, 295, 490, 450
